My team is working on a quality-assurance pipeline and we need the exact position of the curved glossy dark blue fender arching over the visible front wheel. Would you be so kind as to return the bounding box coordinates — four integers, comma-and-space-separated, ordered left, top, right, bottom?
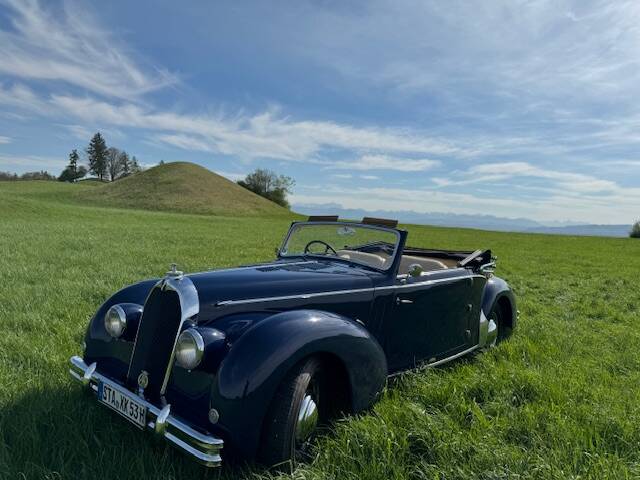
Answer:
211, 310, 387, 457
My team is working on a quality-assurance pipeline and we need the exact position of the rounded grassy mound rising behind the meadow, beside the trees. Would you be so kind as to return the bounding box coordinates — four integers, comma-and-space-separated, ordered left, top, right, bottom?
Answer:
76, 162, 291, 216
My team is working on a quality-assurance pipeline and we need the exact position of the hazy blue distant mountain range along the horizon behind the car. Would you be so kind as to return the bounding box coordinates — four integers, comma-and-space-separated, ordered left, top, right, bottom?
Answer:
291, 203, 631, 237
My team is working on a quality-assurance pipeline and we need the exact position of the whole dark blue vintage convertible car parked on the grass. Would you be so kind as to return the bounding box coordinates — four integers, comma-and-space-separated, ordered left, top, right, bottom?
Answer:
70, 217, 517, 466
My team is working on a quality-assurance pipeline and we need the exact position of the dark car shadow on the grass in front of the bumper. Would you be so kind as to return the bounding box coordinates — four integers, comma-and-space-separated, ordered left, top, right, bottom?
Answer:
0, 385, 266, 480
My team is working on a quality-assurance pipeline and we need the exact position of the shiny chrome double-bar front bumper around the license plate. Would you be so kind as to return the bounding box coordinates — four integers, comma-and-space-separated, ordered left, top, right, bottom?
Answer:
69, 356, 224, 467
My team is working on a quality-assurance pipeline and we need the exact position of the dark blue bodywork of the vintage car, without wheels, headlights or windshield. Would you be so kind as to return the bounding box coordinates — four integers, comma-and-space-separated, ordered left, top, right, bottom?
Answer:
72, 222, 517, 465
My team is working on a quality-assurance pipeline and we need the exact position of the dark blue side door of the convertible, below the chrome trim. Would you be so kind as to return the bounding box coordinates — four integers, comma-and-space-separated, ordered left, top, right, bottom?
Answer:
385, 274, 480, 370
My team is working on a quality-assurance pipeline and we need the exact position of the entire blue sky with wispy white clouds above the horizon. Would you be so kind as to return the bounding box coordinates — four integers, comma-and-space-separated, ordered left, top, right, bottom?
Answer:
0, 0, 640, 223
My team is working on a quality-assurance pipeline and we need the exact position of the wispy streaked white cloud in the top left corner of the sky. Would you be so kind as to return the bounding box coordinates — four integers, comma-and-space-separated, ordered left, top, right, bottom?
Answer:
0, 0, 176, 98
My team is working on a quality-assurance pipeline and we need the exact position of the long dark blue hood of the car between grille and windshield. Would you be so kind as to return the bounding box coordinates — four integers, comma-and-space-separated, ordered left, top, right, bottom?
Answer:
188, 260, 373, 316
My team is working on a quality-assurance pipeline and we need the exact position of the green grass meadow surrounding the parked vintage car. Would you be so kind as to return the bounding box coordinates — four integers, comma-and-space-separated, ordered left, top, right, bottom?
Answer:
0, 182, 640, 480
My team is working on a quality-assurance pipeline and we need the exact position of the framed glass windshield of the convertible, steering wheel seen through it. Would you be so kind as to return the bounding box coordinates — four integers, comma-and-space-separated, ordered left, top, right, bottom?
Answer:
280, 222, 400, 270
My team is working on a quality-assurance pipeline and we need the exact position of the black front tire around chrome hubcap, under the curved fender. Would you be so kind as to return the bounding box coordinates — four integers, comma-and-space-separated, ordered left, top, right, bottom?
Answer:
258, 358, 326, 471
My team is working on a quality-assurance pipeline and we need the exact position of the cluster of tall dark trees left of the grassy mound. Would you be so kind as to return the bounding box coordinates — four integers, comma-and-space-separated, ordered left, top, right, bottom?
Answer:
58, 132, 141, 182
